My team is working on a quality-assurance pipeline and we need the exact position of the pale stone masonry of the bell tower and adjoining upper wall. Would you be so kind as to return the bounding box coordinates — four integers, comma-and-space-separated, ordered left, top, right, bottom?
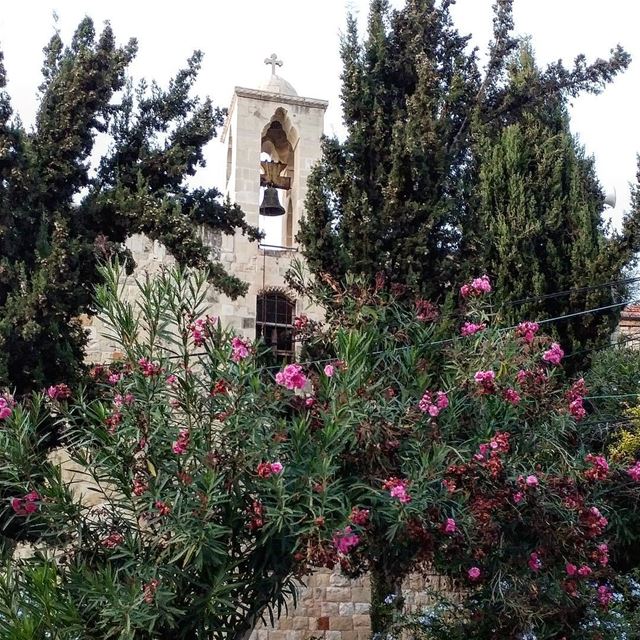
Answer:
85, 74, 328, 362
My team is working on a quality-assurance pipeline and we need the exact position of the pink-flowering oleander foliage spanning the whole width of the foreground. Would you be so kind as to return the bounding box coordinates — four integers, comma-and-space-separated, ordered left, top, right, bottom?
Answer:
0, 270, 640, 640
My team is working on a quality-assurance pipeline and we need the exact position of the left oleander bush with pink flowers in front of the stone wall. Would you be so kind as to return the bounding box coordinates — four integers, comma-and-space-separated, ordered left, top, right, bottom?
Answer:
0, 262, 347, 640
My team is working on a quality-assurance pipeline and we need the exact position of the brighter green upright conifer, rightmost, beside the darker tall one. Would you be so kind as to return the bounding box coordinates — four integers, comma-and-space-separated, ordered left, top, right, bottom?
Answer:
463, 44, 639, 363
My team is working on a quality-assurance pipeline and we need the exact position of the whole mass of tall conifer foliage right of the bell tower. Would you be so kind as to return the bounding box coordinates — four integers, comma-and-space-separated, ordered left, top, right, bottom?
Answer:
299, 0, 640, 360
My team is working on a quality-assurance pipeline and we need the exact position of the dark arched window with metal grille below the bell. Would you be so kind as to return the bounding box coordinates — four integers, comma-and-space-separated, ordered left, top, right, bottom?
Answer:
256, 291, 295, 362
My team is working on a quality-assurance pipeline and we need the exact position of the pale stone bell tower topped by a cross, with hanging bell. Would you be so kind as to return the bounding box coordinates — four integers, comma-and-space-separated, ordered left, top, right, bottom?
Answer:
219, 54, 328, 352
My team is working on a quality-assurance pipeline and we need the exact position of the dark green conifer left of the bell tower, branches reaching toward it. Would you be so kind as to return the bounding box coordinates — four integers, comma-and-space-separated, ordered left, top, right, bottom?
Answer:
0, 18, 256, 392
